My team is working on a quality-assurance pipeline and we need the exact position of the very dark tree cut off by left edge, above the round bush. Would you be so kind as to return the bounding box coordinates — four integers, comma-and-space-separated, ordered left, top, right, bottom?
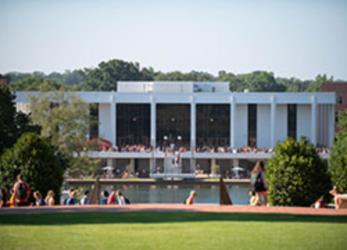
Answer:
0, 85, 40, 155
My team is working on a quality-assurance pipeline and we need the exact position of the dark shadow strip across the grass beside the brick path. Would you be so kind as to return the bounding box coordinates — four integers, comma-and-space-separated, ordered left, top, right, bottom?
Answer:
0, 212, 347, 225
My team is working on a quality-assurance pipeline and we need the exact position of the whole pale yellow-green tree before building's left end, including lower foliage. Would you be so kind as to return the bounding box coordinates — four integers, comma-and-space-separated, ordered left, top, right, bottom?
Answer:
30, 91, 98, 177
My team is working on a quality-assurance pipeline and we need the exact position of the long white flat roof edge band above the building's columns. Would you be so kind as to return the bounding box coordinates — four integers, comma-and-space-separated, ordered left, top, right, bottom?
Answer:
16, 91, 336, 104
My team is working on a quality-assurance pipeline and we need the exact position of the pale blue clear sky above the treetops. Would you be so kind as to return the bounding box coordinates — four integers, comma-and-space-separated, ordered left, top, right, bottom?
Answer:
0, 0, 347, 80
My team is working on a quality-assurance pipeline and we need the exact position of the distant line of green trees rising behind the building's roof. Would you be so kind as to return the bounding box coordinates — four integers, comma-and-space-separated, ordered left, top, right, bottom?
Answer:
4, 59, 340, 92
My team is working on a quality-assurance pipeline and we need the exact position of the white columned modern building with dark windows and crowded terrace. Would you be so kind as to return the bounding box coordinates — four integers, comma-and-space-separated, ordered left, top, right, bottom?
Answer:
16, 82, 335, 178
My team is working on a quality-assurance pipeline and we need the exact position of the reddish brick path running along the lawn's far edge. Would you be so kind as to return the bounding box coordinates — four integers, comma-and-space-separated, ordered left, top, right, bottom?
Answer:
0, 203, 347, 216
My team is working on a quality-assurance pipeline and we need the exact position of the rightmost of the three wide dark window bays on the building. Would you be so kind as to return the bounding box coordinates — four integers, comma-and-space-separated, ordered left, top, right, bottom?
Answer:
196, 104, 230, 147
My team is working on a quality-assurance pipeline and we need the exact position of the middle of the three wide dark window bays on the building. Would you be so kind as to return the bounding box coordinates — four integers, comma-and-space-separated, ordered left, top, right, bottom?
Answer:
156, 104, 190, 147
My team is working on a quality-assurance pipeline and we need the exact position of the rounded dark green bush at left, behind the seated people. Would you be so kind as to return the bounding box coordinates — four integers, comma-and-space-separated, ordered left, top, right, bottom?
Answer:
0, 133, 66, 201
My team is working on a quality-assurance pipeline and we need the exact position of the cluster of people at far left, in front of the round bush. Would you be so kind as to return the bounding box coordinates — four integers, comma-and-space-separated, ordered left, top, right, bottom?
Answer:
0, 175, 55, 207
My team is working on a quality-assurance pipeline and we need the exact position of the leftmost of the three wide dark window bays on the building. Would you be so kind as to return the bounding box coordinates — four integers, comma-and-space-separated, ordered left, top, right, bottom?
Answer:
116, 103, 151, 146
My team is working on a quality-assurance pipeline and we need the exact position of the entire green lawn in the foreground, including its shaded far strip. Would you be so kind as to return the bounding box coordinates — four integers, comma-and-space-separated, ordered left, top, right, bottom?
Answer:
0, 212, 347, 250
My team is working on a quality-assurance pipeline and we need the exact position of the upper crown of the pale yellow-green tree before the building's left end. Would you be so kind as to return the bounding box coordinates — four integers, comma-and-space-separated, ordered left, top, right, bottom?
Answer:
30, 90, 89, 154
